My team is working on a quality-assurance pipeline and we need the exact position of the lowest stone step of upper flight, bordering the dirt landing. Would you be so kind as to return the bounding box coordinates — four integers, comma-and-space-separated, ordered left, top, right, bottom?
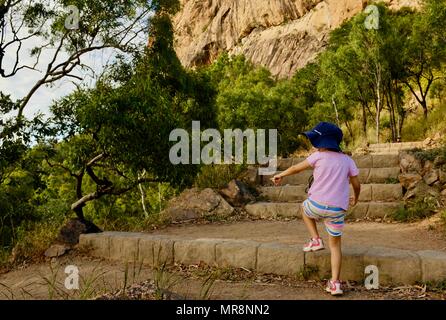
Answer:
245, 201, 403, 219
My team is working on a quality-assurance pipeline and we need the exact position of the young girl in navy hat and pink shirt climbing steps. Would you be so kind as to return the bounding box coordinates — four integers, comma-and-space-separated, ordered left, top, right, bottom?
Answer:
272, 122, 361, 295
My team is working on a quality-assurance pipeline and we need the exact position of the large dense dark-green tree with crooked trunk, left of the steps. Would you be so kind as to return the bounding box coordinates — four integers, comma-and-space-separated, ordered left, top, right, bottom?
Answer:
44, 3, 215, 225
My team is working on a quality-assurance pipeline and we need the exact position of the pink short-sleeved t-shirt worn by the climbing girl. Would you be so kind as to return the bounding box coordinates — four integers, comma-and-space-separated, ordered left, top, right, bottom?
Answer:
307, 151, 359, 210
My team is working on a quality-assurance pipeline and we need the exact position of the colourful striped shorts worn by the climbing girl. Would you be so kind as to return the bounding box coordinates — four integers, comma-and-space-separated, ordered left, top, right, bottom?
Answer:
302, 199, 345, 237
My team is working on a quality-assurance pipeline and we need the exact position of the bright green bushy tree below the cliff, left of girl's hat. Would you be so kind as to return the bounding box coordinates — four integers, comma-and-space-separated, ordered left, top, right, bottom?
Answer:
208, 54, 306, 155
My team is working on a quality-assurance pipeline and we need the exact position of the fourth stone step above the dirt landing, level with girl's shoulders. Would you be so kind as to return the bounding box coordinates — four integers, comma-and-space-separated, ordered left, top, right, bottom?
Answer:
276, 154, 399, 170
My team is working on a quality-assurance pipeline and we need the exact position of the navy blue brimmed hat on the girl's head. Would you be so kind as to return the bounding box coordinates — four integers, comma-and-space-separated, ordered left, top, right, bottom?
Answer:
304, 122, 343, 151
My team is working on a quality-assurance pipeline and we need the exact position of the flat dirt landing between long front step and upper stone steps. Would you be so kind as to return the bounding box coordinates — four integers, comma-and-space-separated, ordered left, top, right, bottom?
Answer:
147, 220, 446, 251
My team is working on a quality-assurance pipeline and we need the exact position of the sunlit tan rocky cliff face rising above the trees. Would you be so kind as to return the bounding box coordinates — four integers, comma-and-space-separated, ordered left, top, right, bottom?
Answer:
174, 0, 419, 77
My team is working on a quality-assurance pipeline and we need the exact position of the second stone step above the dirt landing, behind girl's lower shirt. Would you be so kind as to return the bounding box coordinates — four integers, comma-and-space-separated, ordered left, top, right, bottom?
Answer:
258, 184, 403, 202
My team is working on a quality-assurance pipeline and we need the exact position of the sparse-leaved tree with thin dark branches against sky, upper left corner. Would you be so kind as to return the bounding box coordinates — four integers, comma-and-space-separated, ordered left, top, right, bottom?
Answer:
0, 0, 155, 198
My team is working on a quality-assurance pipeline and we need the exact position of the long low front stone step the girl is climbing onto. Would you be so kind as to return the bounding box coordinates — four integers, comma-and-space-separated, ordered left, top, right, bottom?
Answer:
79, 232, 446, 285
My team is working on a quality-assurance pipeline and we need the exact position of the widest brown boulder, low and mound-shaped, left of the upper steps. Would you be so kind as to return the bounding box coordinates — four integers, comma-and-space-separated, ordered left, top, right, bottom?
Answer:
161, 188, 235, 222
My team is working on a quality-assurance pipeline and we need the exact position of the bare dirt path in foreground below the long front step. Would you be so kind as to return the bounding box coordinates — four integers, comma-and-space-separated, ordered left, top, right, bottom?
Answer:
0, 254, 446, 300
